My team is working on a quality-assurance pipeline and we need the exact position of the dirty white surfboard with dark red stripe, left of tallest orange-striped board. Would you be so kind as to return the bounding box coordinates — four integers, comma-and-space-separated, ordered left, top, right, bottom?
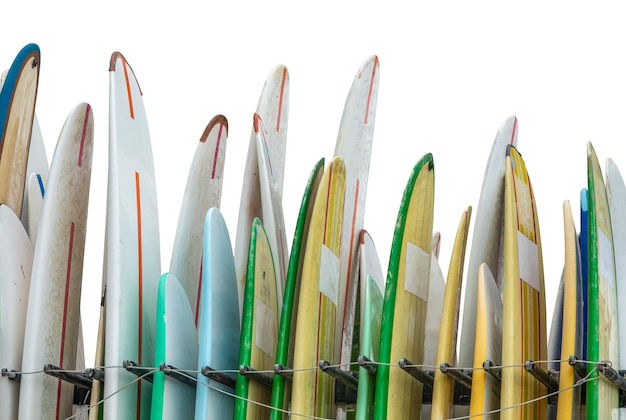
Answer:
19, 103, 94, 419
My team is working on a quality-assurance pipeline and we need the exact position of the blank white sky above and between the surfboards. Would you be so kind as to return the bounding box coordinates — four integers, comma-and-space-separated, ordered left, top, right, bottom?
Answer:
0, 0, 626, 366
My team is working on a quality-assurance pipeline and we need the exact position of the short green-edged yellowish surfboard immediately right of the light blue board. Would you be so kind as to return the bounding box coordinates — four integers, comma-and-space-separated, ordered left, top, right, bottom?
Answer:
233, 217, 279, 420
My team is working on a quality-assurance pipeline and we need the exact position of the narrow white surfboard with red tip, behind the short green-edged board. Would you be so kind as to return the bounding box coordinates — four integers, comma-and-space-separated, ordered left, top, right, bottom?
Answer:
254, 114, 289, 316
